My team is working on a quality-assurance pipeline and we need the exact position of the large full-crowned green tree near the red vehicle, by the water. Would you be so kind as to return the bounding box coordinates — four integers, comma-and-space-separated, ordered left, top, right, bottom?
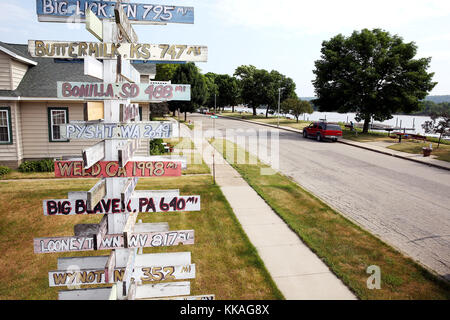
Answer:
313, 29, 436, 132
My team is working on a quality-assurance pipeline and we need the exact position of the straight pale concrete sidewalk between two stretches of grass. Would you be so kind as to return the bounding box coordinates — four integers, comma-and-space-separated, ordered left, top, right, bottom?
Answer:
181, 125, 357, 300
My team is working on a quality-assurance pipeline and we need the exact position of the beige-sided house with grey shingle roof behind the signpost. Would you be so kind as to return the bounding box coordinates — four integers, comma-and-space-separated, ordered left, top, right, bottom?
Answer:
0, 42, 156, 168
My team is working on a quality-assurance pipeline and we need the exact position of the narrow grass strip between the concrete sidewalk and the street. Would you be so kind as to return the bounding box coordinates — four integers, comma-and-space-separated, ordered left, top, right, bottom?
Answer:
212, 139, 450, 300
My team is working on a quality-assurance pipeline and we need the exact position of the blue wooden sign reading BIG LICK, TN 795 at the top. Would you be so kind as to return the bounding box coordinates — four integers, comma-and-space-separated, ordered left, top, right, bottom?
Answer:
36, 0, 194, 24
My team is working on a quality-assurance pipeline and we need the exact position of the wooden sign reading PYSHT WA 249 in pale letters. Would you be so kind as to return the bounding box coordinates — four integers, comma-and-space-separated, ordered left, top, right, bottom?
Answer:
59, 121, 176, 140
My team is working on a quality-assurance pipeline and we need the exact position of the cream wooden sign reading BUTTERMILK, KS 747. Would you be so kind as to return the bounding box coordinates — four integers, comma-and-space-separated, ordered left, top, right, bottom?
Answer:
28, 40, 208, 62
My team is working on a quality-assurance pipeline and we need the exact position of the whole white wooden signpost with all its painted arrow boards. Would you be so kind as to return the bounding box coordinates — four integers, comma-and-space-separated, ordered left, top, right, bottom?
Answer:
32, 0, 215, 300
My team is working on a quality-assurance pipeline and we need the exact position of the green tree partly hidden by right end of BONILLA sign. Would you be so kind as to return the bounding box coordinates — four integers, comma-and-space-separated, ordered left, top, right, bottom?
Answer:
169, 62, 208, 121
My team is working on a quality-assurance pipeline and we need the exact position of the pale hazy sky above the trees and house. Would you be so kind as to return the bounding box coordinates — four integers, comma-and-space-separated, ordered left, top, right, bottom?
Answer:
0, 0, 450, 97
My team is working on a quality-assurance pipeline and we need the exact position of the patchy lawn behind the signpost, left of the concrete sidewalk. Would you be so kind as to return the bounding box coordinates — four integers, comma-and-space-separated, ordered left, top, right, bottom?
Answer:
0, 176, 283, 300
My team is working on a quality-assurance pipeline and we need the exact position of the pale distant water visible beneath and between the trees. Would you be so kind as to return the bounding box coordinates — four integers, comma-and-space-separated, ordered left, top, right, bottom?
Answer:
225, 106, 444, 136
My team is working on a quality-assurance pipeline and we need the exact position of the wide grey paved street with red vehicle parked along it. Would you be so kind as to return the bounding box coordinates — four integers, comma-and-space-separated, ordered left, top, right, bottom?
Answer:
188, 114, 450, 280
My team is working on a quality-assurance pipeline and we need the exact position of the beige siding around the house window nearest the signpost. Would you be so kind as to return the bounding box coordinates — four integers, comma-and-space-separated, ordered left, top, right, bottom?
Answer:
21, 102, 99, 159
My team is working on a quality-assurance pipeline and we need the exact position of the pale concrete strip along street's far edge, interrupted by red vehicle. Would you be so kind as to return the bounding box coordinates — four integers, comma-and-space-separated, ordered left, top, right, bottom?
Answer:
218, 115, 450, 170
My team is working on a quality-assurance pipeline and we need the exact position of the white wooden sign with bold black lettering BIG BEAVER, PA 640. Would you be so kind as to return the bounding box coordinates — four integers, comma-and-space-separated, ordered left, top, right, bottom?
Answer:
42, 193, 200, 216
